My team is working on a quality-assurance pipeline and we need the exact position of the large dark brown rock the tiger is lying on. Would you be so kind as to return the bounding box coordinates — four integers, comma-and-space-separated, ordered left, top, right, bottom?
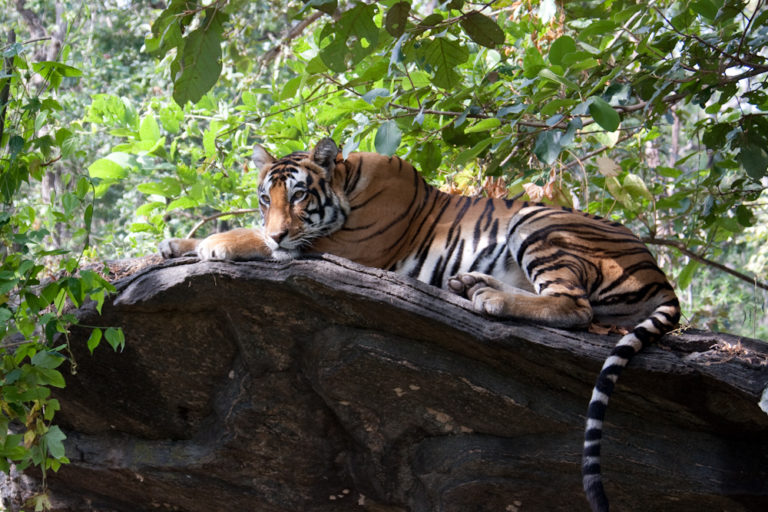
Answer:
3, 256, 768, 512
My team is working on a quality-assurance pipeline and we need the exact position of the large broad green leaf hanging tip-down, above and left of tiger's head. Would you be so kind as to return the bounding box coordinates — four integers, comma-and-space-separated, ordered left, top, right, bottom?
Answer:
172, 7, 227, 106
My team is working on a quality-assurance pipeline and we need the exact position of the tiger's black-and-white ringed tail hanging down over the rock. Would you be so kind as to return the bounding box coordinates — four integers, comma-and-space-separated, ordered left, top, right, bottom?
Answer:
582, 292, 680, 512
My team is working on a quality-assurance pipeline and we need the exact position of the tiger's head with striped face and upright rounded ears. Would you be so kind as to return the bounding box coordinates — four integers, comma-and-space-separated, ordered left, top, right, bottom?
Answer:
253, 138, 349, 258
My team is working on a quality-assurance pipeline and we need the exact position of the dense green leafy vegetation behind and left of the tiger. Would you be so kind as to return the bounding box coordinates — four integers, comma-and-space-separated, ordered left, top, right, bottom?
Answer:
0, 0, 768, 508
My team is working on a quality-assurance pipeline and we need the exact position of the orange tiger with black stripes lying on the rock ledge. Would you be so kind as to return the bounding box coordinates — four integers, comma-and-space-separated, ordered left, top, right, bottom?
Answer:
159, 138, 680, 512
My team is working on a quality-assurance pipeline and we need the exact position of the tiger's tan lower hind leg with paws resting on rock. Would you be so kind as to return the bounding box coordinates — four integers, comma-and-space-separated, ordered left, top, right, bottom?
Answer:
447, 272, 592, 328
